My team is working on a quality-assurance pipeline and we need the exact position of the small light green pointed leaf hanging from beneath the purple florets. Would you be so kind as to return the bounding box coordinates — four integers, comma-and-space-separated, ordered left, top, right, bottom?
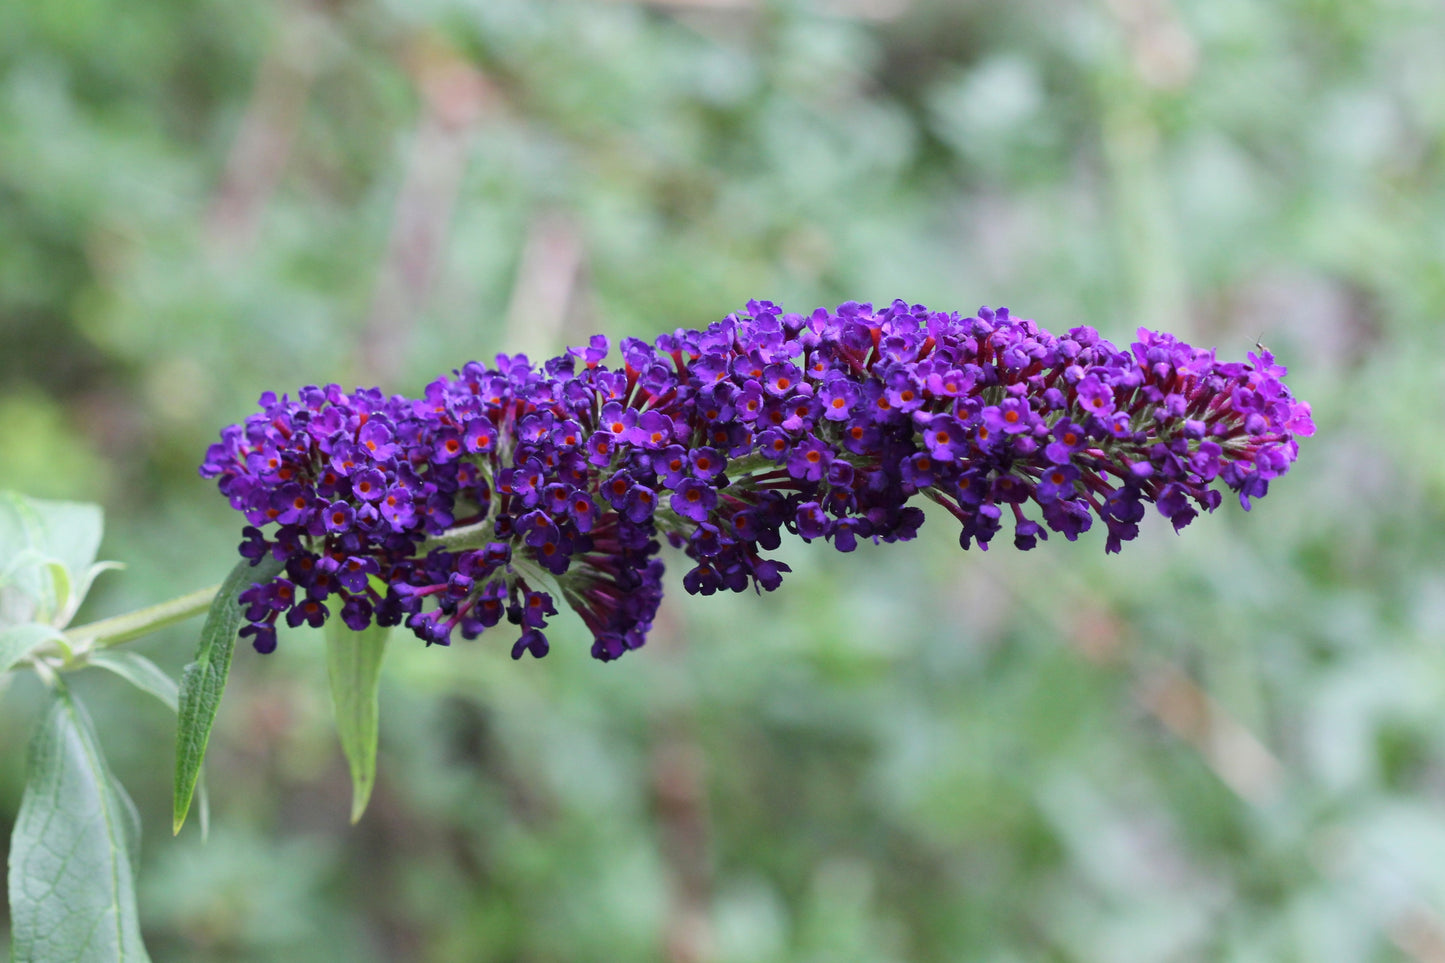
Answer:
327, 619, 392, 823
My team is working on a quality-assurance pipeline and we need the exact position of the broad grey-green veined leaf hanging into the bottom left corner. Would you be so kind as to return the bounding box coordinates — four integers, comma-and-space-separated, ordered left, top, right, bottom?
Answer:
9, 685, 150, 963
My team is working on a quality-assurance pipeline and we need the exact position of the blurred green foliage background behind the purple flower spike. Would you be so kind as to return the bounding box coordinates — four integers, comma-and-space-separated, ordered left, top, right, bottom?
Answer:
0, 0, 1445, 963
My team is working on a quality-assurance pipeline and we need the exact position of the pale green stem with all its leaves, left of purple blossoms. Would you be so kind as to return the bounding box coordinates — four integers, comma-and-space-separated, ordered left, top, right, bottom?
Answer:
0, 492, 387, 963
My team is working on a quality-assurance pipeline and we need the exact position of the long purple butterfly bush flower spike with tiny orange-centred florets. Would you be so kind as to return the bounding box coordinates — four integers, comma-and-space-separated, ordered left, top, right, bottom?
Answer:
201, 301, 1314, 661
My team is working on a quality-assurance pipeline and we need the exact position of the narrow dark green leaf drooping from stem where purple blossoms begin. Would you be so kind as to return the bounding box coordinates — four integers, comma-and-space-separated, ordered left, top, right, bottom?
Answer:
172, 555, 282, 833
